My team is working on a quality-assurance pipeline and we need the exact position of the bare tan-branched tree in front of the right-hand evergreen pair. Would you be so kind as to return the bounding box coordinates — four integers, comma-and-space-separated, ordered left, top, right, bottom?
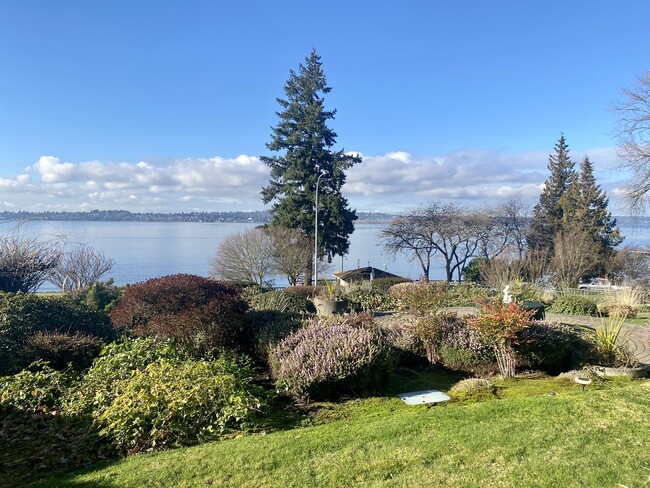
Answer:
551, 232, 597, 288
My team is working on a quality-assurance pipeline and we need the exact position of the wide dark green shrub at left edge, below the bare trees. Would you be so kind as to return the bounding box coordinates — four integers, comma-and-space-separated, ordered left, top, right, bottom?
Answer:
0, 293, 115, 373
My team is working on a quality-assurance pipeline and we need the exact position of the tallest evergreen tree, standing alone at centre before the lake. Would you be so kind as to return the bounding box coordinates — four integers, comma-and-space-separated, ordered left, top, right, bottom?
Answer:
261, 51, 361, 266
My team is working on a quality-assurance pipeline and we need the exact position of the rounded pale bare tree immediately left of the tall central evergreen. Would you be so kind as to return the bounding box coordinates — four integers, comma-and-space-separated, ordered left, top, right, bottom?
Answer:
210, 228, 273, 285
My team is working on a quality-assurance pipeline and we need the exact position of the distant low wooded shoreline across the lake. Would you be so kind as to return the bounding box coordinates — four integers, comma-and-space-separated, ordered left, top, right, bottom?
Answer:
0, 210, 395, 224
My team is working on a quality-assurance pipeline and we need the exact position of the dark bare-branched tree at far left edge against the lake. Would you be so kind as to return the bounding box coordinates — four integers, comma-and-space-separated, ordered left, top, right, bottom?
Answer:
0, 224, 61, 293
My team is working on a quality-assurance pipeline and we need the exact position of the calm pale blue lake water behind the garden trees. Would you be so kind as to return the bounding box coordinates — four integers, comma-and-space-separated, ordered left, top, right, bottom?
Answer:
0, 220, 650, 291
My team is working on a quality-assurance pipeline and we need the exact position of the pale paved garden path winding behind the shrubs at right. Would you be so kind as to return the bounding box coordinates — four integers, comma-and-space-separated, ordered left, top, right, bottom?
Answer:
377, 307, 650, 369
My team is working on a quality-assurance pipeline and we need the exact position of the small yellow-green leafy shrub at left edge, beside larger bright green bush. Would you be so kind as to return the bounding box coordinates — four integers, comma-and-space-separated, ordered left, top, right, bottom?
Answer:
0, 361, 72, 413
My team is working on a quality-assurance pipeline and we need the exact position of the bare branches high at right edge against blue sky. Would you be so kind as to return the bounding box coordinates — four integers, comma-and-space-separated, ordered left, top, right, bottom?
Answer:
612, 71, 650, 213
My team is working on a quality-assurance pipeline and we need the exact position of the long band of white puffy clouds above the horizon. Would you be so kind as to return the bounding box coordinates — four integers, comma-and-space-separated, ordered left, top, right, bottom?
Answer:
0, 148, 624, 212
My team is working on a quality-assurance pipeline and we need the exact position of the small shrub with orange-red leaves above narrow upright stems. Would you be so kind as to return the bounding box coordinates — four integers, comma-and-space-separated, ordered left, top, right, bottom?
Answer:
470, 302, 534, 378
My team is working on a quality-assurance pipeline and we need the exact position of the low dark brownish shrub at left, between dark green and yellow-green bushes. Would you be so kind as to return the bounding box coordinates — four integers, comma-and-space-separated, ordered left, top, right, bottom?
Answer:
25, 332, 102, 371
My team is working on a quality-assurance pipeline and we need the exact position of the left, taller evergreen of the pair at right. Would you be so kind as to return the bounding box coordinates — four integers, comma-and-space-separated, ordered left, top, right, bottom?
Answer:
526, 134, 576, 255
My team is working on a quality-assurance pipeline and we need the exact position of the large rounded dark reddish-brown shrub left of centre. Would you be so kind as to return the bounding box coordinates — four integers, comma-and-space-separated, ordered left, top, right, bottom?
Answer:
110, 274, 248, 354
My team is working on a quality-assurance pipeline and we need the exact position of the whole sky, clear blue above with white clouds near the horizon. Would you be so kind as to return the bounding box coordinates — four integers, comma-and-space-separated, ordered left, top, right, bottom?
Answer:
0, 0, 650, 213
